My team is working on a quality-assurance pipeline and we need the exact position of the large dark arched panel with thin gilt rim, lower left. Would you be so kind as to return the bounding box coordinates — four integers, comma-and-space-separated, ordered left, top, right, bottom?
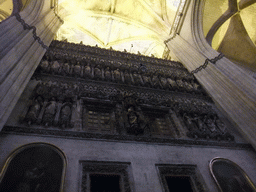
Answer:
0, 143, 66, 192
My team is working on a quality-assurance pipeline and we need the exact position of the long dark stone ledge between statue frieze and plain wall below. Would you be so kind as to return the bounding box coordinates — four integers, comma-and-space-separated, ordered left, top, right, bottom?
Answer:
1, 126, 254, 151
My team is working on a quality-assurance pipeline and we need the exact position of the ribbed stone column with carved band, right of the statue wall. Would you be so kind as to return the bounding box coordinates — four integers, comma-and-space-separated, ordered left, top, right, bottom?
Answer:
166, 1, 256, 148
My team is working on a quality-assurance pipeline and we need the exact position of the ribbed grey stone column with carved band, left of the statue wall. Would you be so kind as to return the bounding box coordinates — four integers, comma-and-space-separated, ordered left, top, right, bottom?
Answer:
0, 0, 62, 130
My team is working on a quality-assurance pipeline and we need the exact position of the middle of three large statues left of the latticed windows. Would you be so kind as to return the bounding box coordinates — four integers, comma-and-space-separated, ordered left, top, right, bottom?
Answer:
43, 97, 57, 126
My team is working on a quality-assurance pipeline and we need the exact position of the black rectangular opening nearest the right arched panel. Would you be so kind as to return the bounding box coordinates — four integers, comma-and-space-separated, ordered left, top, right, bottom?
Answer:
165, 176, 193, 192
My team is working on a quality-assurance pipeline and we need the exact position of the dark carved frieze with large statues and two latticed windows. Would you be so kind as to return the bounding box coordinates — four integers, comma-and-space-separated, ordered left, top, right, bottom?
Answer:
17, 81, 234, 140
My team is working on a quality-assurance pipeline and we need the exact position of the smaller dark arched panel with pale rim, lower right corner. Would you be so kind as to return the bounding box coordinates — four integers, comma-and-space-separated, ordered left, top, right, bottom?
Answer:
210, 158, 256, 192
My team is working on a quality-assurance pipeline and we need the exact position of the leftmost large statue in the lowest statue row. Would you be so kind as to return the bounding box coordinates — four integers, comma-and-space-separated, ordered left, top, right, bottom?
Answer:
25, 96, 43, 125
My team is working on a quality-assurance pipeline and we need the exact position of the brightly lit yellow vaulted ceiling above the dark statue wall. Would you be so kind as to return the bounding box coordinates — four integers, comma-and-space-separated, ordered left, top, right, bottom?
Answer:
57, 0, 180, 58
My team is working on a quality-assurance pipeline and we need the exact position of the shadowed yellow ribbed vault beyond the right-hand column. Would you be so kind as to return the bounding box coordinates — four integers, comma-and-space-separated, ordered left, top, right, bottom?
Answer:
203, 0, 256, 72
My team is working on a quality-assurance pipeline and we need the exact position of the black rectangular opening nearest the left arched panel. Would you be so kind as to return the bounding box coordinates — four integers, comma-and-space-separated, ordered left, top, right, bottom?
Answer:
90, 174, 121, 192
